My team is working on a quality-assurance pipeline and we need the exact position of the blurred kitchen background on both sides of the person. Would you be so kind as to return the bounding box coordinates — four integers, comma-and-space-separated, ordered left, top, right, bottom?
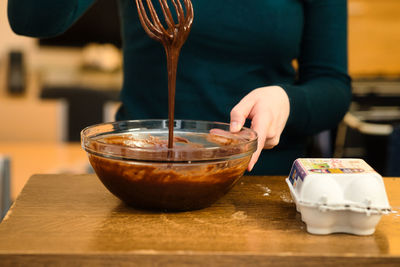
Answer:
0, 0, 400, 218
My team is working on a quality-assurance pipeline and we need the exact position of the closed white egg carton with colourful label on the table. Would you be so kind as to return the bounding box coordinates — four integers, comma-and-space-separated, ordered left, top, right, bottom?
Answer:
286, 158, 391, 235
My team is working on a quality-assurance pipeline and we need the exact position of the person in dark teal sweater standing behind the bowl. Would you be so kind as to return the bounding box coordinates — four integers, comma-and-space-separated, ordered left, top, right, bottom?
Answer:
8, 0, 351, 175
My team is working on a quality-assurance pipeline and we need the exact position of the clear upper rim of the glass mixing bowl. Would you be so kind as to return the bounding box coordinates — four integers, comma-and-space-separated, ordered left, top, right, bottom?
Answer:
81, 119, 257, 163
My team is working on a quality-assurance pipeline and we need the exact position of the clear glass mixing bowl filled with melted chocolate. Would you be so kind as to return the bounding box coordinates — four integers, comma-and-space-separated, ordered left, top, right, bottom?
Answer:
81, 120, 257, 211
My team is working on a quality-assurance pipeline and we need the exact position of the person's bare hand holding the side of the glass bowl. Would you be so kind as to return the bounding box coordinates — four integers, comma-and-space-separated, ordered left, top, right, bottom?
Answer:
230, 86, 290, 171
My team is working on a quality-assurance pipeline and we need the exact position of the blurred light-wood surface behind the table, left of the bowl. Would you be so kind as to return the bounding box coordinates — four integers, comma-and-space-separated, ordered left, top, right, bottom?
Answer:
0, 141, 89, 200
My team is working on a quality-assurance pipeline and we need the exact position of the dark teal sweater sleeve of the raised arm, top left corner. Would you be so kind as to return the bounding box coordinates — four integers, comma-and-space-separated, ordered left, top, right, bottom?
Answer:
8, 0, 96, 37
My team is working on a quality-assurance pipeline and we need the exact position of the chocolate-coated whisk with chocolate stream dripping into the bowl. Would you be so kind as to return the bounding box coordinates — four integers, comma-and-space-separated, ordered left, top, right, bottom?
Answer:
136, 0, 194, 148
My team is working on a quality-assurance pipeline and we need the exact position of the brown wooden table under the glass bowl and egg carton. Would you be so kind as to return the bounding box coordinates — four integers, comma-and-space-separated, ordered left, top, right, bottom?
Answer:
0, 174, 400, 266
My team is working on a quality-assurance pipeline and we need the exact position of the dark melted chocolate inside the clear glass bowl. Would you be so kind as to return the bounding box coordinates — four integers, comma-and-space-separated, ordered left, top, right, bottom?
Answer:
88, 134, 250, 211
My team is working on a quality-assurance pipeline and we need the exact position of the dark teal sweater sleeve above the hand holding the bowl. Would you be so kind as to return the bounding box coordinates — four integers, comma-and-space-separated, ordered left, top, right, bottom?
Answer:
281, 0, 351, 134
